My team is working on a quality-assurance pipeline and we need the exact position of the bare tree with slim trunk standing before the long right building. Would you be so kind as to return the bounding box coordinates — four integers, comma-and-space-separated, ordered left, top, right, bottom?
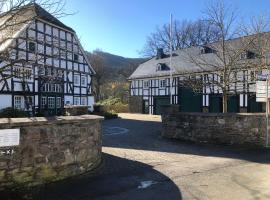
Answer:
186, 1, 270, 113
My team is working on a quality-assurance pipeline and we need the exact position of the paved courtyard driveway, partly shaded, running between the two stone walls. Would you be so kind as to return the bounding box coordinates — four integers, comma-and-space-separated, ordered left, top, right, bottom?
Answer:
3, 114, 270, 200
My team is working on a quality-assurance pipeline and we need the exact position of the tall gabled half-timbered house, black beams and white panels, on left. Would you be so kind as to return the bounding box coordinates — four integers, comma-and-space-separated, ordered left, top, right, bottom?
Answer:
0, 3, 95, 115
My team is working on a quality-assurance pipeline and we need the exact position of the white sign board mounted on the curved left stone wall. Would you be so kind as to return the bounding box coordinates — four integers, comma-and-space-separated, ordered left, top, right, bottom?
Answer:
0, 129, 20, 147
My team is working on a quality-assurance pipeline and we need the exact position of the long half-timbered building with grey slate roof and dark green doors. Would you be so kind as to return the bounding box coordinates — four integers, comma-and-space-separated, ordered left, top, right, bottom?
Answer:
129, 47, 267, 114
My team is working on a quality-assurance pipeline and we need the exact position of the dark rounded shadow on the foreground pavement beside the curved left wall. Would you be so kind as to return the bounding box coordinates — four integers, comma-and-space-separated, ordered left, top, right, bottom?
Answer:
0, 153, 182, 200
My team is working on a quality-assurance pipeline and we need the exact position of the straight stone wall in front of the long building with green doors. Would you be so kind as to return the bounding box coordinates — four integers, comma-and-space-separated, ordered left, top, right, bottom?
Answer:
162, 109, 266, 147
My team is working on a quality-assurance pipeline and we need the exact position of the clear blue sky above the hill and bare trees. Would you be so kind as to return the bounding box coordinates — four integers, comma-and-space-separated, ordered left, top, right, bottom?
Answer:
61, 0, 270, 57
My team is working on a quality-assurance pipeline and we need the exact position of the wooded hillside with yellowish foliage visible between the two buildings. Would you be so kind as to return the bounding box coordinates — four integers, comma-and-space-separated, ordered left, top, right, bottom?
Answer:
87, 50, 146, 108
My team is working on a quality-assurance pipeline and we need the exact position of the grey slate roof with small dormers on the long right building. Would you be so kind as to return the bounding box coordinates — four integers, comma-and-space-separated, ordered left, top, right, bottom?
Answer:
128, 32, 270, 79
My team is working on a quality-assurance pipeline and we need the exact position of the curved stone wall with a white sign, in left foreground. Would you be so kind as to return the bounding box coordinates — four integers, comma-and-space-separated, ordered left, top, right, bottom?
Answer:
0, 115, 103, 189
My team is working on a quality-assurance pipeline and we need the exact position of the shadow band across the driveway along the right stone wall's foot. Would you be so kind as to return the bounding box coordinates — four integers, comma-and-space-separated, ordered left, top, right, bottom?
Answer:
103, 119, 270, 163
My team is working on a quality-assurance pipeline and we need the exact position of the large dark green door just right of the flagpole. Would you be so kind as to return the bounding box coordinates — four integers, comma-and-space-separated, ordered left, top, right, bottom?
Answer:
179, 87, 202, 112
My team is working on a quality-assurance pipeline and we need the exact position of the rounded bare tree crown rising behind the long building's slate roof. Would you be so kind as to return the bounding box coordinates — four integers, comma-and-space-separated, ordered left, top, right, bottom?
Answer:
140, 20, 219, 57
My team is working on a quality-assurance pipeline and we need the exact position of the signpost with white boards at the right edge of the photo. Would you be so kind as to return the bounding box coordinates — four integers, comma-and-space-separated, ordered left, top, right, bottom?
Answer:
256, 74, 270, 148
